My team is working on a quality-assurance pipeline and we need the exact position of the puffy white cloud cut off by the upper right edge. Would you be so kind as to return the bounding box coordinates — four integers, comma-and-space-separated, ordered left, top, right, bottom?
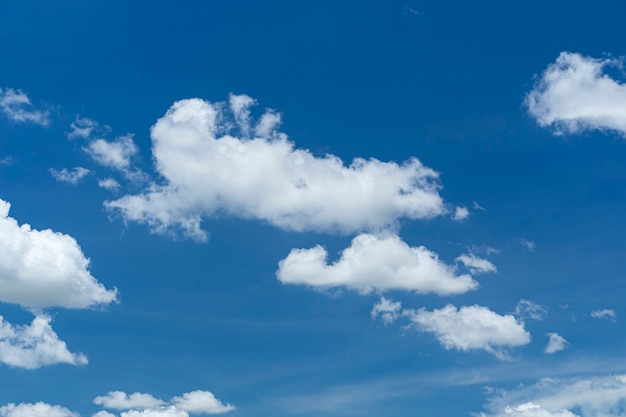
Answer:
525, 52, 626, 135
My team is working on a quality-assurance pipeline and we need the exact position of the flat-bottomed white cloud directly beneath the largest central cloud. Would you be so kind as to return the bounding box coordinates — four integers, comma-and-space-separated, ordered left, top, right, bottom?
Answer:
277, 234, 478, 295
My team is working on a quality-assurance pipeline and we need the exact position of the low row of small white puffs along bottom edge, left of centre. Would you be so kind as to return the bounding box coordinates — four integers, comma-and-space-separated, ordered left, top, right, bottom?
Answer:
93, 390, 235, 417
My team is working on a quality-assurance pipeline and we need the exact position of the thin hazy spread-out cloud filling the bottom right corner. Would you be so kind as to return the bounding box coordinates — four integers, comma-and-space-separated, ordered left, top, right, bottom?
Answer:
488, 375, 626, 417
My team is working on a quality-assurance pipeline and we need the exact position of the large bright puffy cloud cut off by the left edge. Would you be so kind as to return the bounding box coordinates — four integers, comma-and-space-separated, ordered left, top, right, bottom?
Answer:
0, 196, 117, 308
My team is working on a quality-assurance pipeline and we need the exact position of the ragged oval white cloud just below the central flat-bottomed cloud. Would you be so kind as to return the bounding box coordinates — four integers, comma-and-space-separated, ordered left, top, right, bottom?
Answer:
404, 304, 531, 359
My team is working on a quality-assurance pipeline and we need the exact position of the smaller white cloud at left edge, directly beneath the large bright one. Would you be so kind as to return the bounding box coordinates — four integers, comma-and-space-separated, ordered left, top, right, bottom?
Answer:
0, 315, 87, 369
